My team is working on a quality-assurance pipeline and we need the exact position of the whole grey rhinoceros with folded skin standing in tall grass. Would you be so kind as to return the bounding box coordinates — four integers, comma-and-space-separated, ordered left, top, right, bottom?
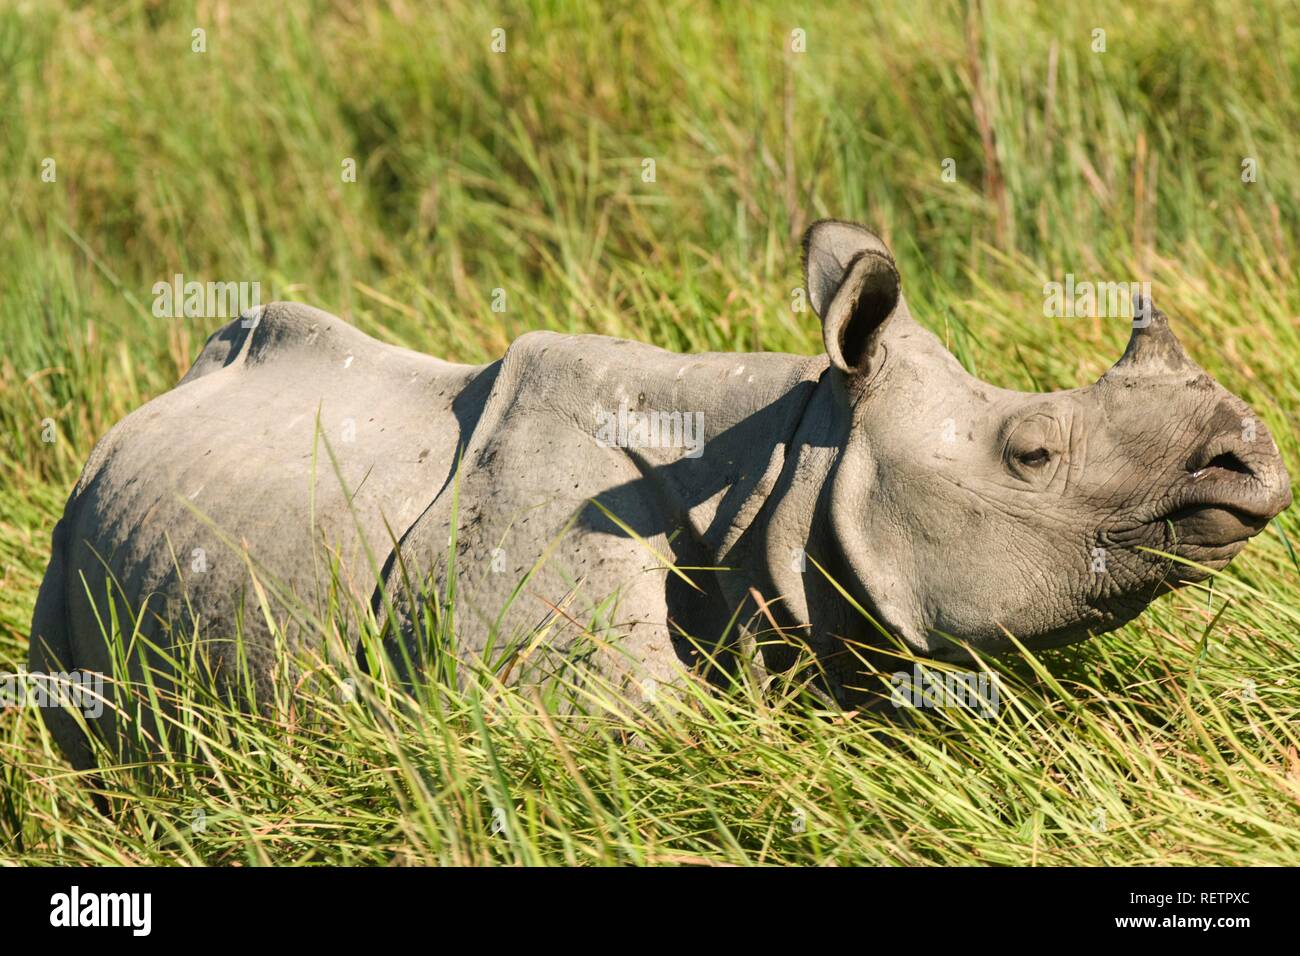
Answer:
31, 221, 1291, 766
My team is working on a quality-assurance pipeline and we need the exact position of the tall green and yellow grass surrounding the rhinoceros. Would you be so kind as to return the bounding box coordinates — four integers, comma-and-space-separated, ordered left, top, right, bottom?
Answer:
0, 0, 1300, 865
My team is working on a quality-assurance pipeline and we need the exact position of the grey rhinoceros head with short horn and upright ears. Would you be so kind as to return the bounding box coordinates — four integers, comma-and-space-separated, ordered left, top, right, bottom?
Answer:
805, 221, 1291, 658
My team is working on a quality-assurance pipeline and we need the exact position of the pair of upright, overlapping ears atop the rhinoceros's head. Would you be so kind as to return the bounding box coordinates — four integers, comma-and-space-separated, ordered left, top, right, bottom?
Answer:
803, 220, 901, 375
